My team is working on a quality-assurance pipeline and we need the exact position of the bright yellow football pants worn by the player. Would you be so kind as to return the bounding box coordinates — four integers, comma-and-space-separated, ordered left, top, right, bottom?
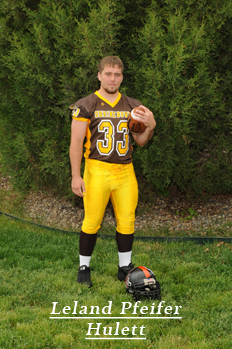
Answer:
82, 159, 138, 234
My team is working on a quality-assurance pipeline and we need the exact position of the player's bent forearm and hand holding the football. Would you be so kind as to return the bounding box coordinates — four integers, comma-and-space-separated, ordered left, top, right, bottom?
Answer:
132, 106, 156, 147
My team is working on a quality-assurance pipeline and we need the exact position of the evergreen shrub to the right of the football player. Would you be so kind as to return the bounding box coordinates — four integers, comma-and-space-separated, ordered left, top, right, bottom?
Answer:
129, 0, 232, 194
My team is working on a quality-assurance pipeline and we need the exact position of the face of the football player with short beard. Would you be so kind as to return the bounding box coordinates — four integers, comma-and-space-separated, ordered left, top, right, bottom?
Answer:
98, 65, 123, 94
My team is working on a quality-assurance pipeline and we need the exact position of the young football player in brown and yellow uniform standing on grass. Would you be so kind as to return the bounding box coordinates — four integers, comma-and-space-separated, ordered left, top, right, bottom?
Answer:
70, 56, 156, 287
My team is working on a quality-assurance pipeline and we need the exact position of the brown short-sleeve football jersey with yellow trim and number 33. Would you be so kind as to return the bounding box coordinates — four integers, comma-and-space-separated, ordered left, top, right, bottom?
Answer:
70, 92, 141, 164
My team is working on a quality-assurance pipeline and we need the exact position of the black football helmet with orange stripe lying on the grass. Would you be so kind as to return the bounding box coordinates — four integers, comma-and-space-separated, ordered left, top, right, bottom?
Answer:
125, 266, 161, 301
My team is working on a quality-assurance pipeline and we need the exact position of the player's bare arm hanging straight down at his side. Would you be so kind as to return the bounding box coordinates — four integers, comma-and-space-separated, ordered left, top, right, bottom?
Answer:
69, 119, 88, 197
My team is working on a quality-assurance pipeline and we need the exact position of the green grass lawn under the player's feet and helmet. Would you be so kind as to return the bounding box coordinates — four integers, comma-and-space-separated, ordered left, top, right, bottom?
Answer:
0, 216, 232, 349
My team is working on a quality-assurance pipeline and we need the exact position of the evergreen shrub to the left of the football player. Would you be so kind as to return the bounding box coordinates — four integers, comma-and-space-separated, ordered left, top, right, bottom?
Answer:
0, 0, 119, 191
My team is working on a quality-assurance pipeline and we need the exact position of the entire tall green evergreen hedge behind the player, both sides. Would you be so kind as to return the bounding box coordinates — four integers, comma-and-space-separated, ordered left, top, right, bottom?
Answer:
0, 0, 232, 194
